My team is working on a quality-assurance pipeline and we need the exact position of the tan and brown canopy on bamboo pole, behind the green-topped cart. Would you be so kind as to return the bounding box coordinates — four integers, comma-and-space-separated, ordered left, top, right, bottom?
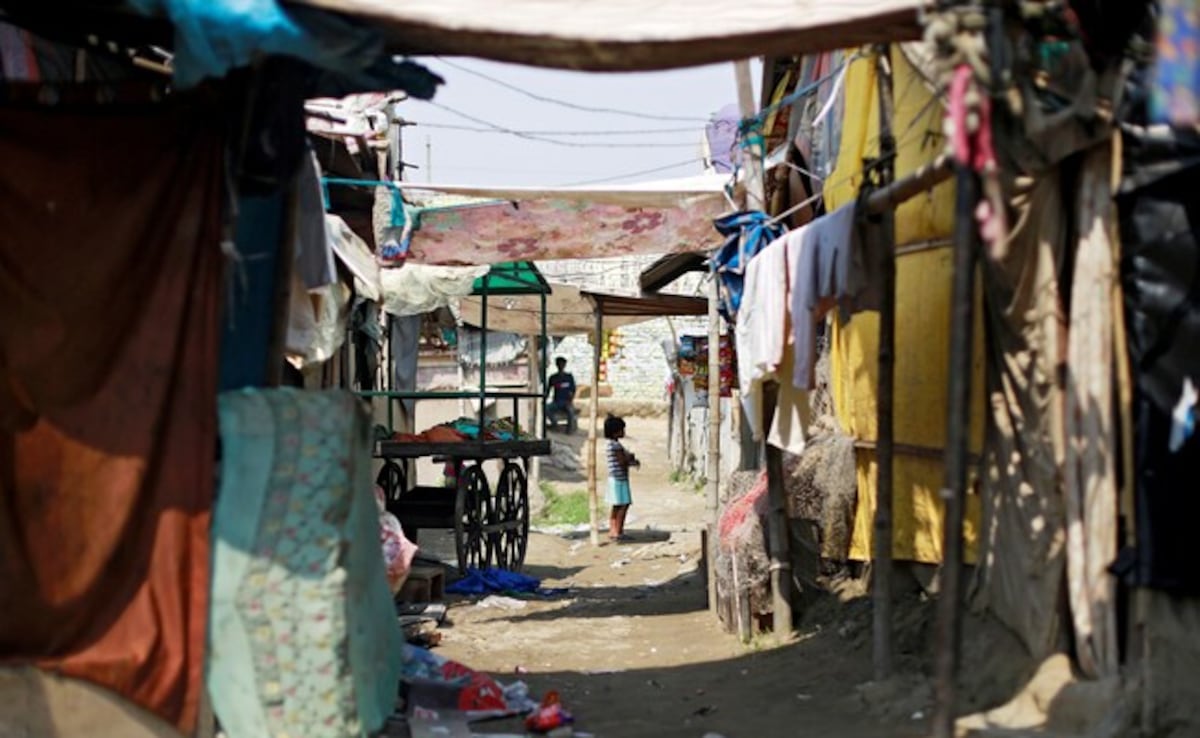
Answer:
460, 283, 708, 336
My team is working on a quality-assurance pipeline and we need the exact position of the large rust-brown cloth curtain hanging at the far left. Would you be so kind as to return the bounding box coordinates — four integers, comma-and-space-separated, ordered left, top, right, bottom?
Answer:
0, 104, 224, 734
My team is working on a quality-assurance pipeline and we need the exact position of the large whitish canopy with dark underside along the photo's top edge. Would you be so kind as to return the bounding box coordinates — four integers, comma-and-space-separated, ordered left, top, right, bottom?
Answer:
292, 0, 926, 71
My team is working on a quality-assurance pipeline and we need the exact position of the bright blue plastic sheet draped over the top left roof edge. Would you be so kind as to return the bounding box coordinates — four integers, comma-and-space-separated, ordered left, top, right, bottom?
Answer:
127, 0, 440, 100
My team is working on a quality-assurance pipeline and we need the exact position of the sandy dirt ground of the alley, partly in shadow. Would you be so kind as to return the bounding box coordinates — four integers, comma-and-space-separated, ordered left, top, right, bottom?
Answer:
422, 418, 926, 738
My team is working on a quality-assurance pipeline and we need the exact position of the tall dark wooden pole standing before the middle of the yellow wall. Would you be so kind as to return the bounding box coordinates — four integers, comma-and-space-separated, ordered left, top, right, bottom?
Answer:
871, 46, 896, 680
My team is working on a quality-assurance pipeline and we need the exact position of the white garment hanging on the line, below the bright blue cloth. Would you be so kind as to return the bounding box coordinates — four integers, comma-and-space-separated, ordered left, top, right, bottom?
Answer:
734, 236, 787, 440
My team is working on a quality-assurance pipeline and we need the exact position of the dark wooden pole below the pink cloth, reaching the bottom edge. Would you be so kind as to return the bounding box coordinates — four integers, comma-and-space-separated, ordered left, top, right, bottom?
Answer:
934, 167, 979, 738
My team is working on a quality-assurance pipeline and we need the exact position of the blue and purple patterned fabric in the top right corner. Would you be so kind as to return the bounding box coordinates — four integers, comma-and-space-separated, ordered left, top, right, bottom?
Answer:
1150, 0, 1200, 126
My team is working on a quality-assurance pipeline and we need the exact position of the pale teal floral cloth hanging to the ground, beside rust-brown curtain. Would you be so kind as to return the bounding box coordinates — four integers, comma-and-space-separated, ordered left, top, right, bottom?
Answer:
208, 389, 402, 738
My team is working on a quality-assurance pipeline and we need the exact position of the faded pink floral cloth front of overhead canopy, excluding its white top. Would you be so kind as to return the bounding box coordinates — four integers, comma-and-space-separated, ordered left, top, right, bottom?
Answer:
409, 198, 725, 264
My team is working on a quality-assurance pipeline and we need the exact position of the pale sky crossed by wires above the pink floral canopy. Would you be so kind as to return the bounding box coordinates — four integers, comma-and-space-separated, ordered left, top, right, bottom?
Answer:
400, 58, 762, 186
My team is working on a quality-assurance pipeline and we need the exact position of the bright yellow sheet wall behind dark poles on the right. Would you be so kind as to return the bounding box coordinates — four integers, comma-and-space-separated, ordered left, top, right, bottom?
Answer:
824, 48, 984, 563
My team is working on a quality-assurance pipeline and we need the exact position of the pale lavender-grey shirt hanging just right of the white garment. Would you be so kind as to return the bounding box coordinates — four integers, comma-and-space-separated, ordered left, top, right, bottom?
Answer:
787, 203, 880, 390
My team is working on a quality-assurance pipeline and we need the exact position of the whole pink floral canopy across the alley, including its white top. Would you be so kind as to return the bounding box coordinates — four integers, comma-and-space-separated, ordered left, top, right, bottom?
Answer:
408, 175, 730, 264
